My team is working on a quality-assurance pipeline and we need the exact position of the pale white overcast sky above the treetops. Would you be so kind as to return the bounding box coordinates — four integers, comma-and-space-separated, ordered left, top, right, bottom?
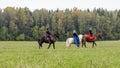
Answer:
0, 0, 120, 11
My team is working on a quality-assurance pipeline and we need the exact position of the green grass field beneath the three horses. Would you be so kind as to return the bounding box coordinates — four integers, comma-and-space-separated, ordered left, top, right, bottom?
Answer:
0, 41, 120, 68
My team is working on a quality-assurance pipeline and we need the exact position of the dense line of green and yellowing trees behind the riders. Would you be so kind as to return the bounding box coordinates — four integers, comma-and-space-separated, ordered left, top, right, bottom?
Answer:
0, 7, 120, 40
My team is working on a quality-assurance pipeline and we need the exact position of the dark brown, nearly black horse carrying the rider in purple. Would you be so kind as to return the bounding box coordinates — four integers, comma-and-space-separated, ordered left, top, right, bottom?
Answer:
38, 32, 59, 49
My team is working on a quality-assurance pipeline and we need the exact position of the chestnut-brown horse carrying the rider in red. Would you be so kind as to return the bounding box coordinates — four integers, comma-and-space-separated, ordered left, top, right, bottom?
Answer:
81, 33, 102, 47
